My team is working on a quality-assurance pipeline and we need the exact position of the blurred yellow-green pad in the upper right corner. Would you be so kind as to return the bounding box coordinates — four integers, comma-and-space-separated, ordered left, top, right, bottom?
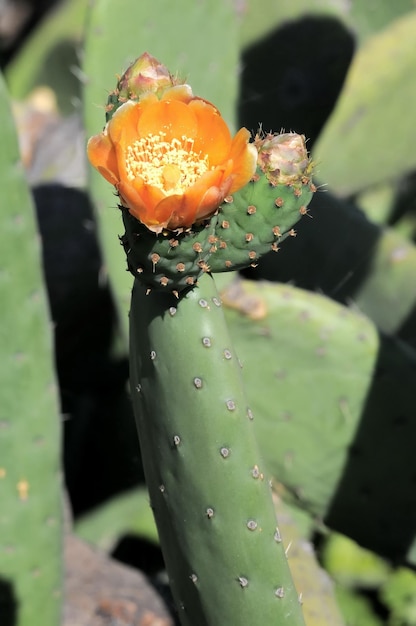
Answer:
314, 11, 416, 196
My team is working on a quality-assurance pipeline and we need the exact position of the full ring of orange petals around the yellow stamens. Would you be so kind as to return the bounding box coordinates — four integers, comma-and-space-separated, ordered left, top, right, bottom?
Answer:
88, 75, 257, 232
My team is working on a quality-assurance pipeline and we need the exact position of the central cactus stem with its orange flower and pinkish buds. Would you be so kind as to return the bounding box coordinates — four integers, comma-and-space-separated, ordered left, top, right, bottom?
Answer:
88, 42, 314, 626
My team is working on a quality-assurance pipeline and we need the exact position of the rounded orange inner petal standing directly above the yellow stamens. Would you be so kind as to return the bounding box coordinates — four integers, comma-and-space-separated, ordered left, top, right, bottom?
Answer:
138, 100, 198, 142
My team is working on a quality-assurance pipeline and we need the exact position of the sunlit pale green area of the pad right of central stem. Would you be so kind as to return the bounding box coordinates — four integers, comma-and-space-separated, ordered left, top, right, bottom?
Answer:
222, 281, 378, 518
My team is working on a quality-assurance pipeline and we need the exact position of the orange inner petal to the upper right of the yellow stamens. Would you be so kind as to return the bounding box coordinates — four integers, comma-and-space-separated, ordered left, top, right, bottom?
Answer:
188, 98, 231, 165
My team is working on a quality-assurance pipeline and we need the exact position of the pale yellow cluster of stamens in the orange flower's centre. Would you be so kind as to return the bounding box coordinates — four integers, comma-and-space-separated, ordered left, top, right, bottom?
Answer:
126, 132, 209, 196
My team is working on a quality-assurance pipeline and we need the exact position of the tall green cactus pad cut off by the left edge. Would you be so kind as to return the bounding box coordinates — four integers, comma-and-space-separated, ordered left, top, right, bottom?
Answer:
0, 70, 61, 626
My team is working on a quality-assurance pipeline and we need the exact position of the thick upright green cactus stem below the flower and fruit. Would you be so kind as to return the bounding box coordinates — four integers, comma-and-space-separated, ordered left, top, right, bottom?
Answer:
130, 275, 304, 626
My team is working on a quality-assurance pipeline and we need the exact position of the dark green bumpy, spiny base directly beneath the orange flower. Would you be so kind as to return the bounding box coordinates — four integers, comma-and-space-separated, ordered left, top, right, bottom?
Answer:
120, 207, 217, 292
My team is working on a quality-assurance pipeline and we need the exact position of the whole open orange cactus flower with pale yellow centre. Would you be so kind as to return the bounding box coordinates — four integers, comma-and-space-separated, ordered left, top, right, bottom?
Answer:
87, 85, 257, 233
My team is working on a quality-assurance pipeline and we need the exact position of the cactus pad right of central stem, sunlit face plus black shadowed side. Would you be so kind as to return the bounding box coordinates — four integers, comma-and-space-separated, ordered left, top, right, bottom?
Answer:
223, 281, 416, 562
